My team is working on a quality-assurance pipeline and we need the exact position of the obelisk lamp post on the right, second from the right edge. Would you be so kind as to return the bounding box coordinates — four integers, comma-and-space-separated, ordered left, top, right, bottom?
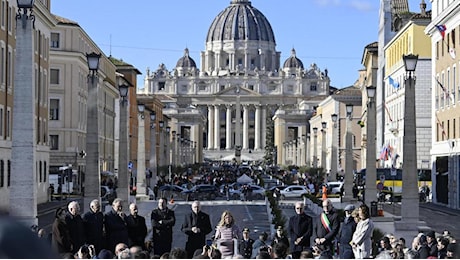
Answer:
364, 86, 377, 206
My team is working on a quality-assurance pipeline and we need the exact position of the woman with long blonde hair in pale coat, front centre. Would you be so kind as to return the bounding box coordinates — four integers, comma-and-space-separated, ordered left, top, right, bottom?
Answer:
214, 210, 241, 258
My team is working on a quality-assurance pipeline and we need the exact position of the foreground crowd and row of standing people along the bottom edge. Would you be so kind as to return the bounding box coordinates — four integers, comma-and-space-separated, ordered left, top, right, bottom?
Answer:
0, 187, 458, 259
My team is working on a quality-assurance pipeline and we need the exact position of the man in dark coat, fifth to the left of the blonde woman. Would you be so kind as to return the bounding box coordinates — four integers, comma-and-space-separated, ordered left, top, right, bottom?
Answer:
83, 199, 105, 254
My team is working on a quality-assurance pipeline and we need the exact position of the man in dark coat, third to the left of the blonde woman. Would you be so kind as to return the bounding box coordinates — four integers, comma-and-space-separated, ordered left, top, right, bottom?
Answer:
126, 203, 147, 250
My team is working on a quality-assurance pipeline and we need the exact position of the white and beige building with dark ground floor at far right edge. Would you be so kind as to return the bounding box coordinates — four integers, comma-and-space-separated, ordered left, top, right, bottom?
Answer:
425, 0, 460, 209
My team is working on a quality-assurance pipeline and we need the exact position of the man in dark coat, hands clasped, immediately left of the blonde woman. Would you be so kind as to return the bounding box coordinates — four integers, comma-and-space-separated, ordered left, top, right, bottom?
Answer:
181, 201, 212, 258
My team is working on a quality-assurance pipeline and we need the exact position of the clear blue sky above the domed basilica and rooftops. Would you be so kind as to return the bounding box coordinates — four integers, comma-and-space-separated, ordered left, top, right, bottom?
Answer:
51, 0, 431, 88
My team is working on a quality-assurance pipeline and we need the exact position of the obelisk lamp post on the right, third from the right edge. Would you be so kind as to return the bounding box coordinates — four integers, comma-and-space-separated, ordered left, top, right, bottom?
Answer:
344, 104, 353, 201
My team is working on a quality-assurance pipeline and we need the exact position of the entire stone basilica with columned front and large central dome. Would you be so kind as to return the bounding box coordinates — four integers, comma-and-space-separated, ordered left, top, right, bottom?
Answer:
138, 0, 330, 163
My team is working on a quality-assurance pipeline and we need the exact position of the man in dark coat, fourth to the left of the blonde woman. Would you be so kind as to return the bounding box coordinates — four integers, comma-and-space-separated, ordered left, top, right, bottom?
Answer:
104, 198, 129, 253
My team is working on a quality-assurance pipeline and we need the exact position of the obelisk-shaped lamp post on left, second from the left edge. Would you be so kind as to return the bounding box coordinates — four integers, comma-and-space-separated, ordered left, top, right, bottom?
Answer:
83, 52, 101, 210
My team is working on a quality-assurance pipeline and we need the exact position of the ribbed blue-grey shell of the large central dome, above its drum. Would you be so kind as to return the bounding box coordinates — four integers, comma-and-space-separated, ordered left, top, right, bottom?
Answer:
206, 0, 275, 43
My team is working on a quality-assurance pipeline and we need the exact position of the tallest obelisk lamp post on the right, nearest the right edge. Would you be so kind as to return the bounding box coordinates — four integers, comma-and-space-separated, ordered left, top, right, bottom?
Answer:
396, 54, 419, 230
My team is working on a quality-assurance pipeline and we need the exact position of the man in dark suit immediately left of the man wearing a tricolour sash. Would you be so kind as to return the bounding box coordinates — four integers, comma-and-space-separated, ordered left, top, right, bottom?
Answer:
288, 202, 313, 258
